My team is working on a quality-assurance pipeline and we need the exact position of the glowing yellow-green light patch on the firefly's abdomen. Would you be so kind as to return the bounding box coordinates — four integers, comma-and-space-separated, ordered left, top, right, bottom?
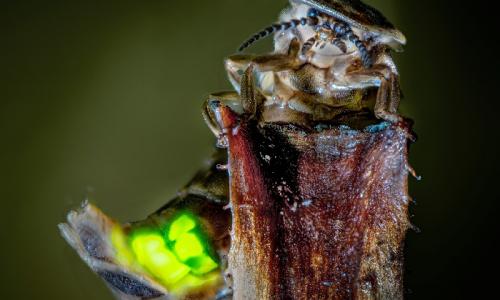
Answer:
111, 213, 220, 293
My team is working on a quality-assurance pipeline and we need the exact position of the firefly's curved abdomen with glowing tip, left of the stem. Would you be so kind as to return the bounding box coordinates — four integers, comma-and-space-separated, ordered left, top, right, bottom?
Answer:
59, 151, 231, 300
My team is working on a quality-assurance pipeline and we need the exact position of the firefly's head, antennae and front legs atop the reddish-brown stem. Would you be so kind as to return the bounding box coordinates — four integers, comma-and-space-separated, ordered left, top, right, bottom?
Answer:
206, 0, 406, 134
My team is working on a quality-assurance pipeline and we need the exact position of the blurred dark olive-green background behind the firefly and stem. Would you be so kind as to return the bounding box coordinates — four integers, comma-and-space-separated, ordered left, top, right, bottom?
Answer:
0, 0, 498, 299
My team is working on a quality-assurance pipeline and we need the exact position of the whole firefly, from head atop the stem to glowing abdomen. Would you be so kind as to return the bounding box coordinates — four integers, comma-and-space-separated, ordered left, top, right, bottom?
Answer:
60, 0, 406, 300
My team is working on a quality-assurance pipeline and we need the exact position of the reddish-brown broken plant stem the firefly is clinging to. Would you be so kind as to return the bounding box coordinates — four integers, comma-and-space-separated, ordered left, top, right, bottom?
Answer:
214, 104, 409, 299
